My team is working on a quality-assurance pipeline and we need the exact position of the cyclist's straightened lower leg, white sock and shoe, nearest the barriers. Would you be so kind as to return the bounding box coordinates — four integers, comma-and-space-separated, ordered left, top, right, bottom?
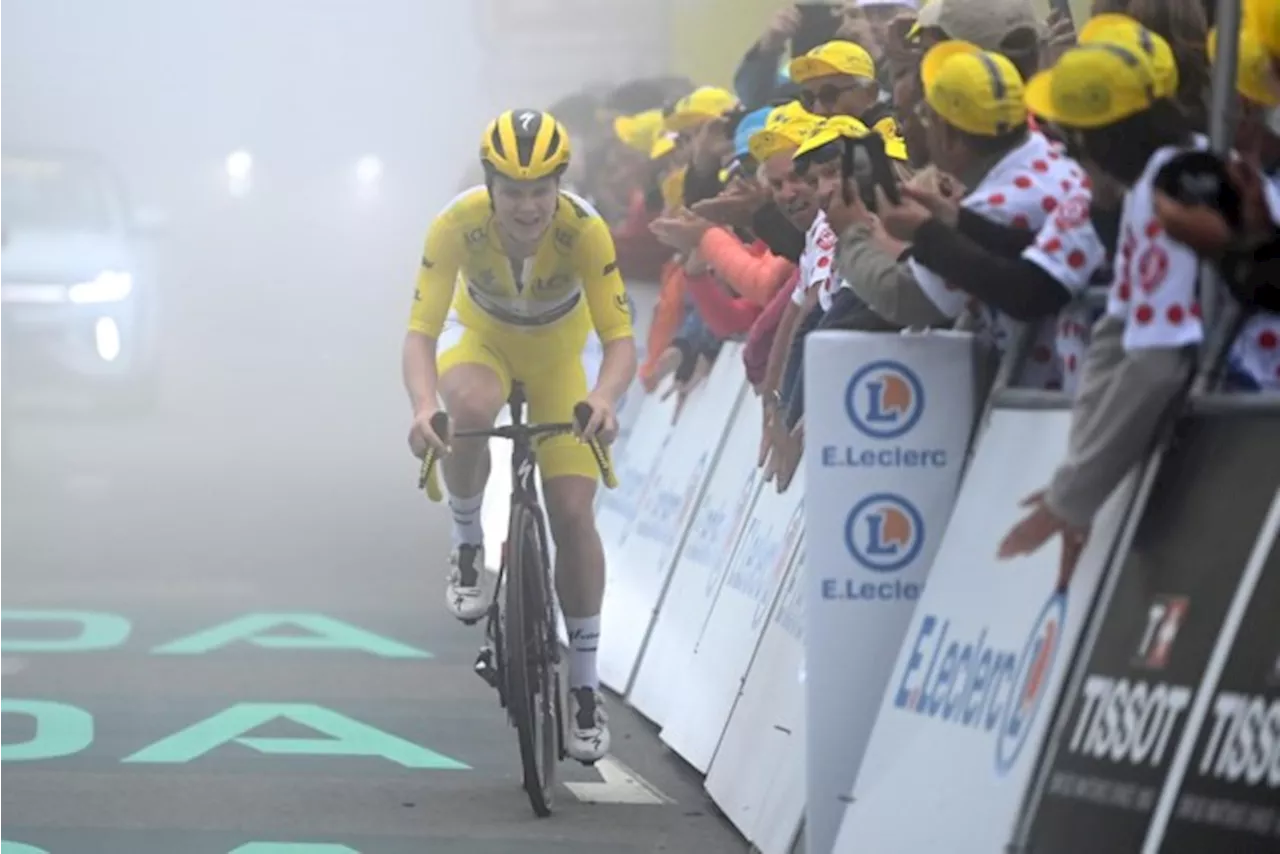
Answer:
543, 475, 609, 763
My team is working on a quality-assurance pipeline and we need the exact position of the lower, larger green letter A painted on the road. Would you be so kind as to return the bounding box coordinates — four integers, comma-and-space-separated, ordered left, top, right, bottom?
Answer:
123, 703, 471, 771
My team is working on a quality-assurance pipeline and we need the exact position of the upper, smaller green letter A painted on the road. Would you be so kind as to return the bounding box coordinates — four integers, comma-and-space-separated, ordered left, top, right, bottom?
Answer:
152, 613, 431, 658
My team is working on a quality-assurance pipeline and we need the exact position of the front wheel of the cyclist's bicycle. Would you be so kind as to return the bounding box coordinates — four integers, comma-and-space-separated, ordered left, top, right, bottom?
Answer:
503, 504, 561, 818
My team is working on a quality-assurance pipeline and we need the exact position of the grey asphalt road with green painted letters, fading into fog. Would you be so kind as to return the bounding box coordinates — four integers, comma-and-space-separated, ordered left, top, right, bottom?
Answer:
0, 315, 746, 854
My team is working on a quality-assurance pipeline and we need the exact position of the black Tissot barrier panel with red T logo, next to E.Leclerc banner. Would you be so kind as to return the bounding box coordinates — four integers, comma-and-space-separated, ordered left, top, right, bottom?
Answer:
1027, 416, 1280, 854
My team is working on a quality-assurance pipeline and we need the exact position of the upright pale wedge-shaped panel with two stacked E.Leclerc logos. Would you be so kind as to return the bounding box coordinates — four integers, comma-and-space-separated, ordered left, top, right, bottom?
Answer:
804, 332, 975, 854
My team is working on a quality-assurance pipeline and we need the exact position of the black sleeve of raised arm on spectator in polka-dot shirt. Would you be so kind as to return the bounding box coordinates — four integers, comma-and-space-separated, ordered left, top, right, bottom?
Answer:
911, 219, 1071, 321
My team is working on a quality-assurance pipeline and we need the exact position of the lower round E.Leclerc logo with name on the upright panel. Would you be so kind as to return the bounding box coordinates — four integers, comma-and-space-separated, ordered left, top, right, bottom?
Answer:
822, 493, 924, 600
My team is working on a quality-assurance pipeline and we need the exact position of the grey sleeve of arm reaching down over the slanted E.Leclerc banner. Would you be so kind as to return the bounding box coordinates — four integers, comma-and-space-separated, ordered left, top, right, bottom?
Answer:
1044, 316, 1193, 528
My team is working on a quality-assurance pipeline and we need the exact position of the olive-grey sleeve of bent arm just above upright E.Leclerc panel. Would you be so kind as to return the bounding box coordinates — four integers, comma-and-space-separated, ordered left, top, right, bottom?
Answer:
836, 224, 954, 328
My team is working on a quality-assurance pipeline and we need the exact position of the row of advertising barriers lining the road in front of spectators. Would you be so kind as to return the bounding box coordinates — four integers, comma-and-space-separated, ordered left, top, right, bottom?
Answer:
471, 294, 1280, 854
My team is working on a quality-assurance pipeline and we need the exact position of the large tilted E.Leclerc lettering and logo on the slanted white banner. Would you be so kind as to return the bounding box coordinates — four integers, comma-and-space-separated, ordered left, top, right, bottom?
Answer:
893, 593, 1066, 776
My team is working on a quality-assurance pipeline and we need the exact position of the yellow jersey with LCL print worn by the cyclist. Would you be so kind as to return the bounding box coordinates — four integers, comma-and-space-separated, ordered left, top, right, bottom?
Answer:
410, 187, 632, 348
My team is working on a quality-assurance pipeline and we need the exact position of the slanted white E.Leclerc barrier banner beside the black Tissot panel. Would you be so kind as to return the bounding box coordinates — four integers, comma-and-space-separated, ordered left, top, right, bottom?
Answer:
834, 408, 1134, 854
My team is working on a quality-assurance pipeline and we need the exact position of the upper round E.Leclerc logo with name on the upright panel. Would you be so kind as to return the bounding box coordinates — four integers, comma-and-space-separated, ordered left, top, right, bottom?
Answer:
822, 360, 947, 469
